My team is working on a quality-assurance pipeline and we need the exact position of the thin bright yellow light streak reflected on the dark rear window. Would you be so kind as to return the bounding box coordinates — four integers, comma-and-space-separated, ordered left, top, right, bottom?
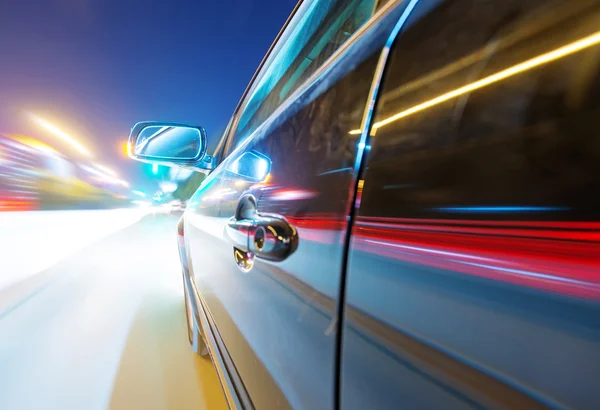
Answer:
349, 32, 600, 135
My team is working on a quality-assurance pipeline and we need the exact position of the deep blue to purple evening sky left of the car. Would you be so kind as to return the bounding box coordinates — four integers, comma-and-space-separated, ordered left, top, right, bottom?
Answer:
0, 0, 296, 192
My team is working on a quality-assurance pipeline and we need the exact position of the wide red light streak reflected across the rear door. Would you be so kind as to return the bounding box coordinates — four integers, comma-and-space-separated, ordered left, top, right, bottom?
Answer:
355, 218, 600, 300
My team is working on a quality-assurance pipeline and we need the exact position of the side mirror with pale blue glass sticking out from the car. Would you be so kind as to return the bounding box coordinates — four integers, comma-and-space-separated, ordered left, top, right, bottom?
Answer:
129, 122, 215, 171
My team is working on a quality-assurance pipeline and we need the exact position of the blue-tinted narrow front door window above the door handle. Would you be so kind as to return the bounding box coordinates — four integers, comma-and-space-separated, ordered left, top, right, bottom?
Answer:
226, 0, 377, 153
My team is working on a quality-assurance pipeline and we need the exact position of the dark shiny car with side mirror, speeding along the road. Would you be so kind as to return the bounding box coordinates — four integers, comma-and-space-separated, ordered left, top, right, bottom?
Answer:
129, 0, 600, 410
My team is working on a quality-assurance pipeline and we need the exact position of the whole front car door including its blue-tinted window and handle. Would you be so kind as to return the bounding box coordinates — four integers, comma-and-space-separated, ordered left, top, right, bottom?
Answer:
185, 0, 414, 410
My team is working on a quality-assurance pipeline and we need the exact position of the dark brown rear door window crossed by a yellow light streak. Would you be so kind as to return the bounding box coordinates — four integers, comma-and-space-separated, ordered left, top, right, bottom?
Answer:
360, 0, 600, 218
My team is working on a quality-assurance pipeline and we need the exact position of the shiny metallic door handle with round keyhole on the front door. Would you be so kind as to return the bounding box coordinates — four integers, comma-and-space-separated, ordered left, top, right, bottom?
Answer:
226, 197, 298, 261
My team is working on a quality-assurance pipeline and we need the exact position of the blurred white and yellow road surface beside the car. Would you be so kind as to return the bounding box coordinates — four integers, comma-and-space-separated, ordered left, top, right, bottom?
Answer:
0, 210, 226, 410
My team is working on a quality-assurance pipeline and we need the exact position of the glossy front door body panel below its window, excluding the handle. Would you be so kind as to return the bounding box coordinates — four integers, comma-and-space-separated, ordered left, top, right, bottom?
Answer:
185, 6, 414, 409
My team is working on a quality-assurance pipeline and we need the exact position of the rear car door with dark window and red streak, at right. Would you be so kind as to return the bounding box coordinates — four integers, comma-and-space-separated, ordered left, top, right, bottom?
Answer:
341, 0, 600, 409
